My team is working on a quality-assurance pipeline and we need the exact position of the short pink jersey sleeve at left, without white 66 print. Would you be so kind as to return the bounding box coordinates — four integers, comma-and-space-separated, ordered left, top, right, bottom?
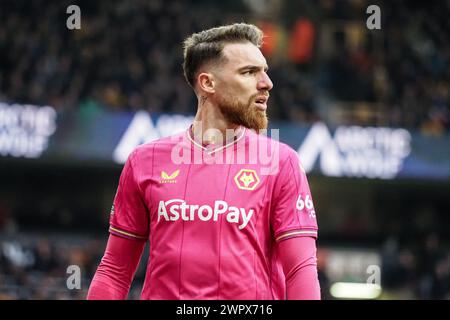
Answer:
109, 150, 149, 240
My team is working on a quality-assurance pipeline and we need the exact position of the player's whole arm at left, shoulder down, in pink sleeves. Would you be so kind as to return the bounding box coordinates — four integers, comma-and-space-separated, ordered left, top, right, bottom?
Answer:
87, 150, 149, 299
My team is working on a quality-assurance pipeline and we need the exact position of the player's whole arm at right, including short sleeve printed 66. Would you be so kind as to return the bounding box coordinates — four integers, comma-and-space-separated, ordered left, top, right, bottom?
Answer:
271, 149, 320, 299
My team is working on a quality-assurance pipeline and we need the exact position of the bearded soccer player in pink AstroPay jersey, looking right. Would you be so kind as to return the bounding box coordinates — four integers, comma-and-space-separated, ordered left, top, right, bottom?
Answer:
87, 23, 320, 300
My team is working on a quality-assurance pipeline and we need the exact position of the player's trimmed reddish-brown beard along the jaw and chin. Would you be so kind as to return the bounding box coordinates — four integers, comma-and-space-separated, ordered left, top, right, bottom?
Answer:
218, 93, 269, 132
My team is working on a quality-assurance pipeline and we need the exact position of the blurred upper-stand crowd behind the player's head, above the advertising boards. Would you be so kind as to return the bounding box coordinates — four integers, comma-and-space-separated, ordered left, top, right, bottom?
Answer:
0, 0, 450, 134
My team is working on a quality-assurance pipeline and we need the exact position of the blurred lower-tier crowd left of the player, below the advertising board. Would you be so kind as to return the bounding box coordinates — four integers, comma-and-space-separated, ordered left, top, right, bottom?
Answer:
0, 233, 145, 300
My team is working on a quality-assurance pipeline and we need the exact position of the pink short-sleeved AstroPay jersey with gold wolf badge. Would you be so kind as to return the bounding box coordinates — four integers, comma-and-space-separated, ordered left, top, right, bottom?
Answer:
110, 128, 317, 300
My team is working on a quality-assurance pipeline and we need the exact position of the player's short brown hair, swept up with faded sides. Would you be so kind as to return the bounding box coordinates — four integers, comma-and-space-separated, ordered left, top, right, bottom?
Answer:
183, 23, 263, 88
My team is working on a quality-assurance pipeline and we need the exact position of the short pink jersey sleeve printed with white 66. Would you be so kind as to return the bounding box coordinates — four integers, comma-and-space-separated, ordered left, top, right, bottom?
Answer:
271, 150, 318, 241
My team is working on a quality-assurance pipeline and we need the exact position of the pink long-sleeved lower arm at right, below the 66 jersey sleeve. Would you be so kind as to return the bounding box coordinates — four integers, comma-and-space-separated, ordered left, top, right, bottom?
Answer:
278, 237, 320, 300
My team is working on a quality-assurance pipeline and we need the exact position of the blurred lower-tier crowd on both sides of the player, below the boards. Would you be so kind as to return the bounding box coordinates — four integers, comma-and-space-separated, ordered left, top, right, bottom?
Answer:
0, 233, 450, 300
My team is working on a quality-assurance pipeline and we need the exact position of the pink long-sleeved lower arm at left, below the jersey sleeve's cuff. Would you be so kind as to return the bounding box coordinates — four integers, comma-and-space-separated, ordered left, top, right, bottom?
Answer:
87, 234, 146, 300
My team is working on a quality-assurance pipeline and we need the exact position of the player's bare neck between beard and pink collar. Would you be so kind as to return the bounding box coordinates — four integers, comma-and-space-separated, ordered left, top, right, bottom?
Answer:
192, 99, 240, 145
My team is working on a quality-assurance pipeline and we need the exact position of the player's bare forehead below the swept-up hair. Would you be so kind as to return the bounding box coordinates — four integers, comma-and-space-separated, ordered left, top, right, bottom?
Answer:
223, 42, 267, 69
